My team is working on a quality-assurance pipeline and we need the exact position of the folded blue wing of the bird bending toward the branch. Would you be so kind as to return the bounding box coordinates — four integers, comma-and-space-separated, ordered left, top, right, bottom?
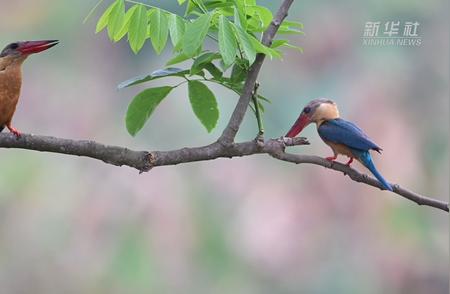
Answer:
318, 118, 381, 151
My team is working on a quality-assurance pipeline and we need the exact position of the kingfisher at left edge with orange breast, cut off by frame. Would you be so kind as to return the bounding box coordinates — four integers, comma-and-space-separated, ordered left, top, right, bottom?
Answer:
0, 40, 58, 137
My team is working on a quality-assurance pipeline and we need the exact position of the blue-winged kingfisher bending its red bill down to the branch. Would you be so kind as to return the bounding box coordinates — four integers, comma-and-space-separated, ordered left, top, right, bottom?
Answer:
286, 98, 392, 191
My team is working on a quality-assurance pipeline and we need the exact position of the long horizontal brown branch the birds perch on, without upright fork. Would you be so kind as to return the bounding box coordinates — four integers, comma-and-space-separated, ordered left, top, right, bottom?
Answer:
0, 134, 449, 212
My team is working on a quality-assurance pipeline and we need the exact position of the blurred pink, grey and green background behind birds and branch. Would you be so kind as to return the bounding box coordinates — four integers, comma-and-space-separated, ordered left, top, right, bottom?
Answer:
0, 0, 449, 294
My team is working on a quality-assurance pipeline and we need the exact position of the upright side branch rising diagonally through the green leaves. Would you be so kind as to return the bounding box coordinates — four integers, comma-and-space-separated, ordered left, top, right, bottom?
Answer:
219, 0, 294, 144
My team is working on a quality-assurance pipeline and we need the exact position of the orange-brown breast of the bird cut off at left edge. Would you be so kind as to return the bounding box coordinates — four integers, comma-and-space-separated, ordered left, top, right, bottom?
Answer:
0, 58, 22, 126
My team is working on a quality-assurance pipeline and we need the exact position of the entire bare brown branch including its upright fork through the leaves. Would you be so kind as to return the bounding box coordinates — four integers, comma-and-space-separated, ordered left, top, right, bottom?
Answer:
0, 0, 449, 212
